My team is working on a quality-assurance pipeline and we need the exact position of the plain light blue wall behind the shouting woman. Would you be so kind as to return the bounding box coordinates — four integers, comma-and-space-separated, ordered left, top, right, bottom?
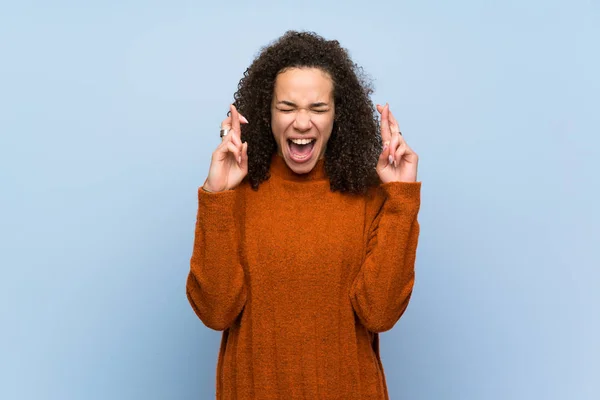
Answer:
0, 0, 600, 400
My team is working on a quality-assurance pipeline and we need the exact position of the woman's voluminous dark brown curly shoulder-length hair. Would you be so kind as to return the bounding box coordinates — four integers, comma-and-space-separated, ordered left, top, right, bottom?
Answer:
234, 31, 382, 193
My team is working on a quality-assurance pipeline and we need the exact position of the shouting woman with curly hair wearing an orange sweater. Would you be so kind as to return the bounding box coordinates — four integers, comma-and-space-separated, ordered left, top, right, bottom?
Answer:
187, 32, 421, 400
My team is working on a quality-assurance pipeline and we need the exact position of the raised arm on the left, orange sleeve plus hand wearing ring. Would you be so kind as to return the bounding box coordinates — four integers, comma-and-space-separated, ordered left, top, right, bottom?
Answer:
186, 105, 248, 330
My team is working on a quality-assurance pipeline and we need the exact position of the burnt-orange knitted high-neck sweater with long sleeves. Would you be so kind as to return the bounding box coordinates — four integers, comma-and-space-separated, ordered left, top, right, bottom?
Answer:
187, 155, 421, 400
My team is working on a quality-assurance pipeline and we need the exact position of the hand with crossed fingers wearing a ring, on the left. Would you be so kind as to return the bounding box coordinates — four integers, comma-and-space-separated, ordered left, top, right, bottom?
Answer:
202, 104, 248, 192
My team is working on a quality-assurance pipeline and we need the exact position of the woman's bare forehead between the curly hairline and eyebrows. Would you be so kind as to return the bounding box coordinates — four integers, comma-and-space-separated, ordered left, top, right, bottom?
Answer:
275, 68, 333, 101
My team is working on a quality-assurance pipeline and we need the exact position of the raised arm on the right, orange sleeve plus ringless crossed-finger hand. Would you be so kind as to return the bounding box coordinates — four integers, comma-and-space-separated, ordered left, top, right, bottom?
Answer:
350, 104, 421, 332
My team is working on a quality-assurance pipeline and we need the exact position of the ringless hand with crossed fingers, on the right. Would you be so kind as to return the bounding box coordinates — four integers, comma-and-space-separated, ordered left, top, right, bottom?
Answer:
377, 104, 419, 183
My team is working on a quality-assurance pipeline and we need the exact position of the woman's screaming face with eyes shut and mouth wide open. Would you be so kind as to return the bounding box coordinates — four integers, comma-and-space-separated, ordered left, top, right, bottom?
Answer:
271, 68, 335, 174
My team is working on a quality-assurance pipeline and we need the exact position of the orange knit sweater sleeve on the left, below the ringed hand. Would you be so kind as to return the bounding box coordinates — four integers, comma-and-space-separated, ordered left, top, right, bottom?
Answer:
186, 188, 247, 330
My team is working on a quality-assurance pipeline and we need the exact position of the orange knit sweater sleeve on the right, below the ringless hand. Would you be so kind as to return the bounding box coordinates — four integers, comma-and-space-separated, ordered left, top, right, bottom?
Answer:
350, 182, 421, 333
